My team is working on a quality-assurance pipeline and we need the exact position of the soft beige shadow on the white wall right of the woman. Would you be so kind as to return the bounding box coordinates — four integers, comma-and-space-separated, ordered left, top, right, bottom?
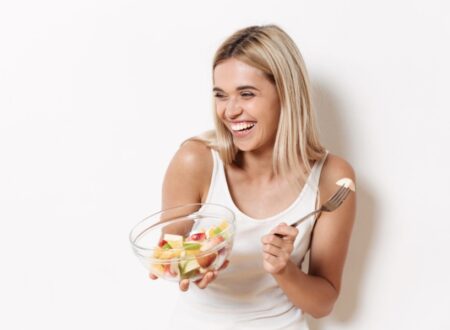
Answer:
308, 82, 375, 330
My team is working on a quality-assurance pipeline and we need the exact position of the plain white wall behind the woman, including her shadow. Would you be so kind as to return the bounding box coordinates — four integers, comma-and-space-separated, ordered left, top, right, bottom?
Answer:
0, 0, 450, 329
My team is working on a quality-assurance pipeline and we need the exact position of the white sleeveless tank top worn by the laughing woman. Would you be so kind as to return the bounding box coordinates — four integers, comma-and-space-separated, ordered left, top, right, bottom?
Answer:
170, 150, 326, 330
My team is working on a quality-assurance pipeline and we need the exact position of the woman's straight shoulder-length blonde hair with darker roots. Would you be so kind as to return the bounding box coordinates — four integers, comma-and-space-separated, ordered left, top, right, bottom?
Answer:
189, 25, 325, 179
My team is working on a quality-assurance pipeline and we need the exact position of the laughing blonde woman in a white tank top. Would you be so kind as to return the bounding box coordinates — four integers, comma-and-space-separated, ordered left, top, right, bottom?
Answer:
150, 25, 355, 329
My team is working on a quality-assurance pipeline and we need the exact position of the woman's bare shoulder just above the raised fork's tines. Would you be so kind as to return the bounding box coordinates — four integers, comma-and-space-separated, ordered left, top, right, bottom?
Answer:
319, 153, 356, 201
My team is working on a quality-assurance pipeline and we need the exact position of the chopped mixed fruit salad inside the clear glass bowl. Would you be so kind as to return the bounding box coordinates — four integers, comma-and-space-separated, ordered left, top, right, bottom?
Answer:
150, 220, 230, 280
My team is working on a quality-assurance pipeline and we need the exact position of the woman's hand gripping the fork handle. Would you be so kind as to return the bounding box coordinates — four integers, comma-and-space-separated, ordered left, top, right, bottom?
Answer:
261, 223, 298, 274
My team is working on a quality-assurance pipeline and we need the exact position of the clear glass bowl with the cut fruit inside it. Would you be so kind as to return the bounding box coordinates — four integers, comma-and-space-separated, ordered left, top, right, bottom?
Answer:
129, 203, 235, 281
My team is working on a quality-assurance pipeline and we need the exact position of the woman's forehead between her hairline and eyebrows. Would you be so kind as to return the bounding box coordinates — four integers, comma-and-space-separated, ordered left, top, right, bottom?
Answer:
213, 58, 269, 87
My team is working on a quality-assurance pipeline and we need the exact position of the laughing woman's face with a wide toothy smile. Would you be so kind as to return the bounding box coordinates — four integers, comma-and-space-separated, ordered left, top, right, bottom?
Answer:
213, 58, 280, 151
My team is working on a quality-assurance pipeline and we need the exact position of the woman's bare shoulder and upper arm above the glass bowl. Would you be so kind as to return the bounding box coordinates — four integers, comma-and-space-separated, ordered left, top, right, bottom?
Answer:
163, 140, 213, 207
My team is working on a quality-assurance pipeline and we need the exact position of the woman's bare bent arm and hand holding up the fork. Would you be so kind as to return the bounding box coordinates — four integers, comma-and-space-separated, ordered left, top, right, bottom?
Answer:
263, 155, 356, 318
